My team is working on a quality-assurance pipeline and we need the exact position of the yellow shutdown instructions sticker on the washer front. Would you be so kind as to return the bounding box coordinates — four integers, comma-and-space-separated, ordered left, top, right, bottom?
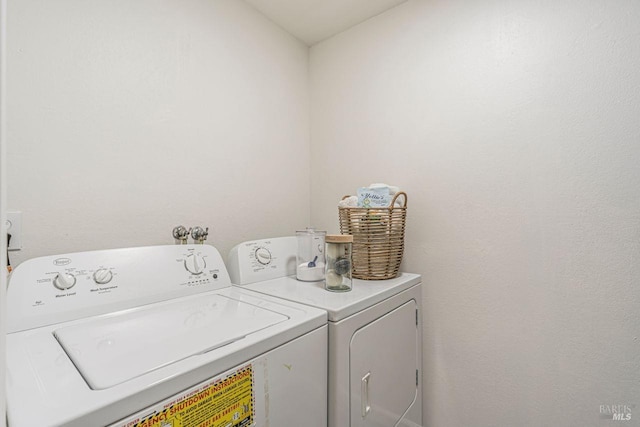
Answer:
125, 365, 255, 427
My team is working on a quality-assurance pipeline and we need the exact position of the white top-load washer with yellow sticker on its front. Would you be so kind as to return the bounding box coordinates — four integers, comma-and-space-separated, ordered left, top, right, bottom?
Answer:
6, 245, 327, 427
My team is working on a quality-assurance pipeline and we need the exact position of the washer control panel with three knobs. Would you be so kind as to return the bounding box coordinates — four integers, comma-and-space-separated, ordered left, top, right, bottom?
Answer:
7, 245, 231, 332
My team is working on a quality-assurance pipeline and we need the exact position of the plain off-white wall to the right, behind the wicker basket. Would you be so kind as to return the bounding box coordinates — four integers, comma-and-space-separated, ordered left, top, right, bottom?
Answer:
310, 0, 640, 427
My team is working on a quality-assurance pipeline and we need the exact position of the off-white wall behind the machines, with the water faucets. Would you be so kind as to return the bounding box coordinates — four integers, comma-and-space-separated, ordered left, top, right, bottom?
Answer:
7, 0, 310, 264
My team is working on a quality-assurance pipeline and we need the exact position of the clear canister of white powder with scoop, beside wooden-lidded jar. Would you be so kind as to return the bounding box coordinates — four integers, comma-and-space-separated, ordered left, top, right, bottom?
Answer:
296, 227, 327, 282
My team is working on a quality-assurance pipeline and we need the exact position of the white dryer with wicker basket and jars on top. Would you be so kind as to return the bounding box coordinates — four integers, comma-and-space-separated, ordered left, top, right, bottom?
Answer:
227, 237, 422, 427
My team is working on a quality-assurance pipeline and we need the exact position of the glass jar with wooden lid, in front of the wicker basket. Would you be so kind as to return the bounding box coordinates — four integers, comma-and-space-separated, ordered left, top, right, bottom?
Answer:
324, 234, 353, 292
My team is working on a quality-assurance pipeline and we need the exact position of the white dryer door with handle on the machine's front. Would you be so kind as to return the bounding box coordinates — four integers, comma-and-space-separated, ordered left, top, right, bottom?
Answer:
350, 300, 419, 427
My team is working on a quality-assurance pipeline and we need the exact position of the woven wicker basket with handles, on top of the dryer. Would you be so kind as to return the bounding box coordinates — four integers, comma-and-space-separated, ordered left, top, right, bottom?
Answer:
338, 191, 407, 280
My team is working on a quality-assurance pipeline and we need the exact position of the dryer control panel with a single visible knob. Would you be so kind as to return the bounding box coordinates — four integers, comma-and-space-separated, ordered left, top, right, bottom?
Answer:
227, 236, 298, 285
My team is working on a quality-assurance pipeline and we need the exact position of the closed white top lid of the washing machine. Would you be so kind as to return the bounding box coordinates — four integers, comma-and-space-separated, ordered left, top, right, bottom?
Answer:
54, 294, 289, 390
